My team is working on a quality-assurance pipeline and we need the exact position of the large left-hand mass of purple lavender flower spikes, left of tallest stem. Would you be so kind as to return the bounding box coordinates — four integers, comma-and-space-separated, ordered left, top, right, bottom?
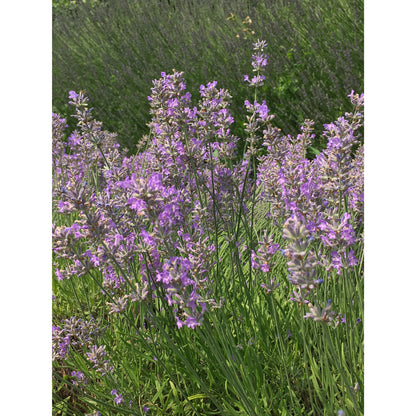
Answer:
53, 71, 252, 328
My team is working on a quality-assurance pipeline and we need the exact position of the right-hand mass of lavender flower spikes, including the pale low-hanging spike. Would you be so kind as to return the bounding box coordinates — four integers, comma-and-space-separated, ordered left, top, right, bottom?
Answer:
257, 91, 364, 322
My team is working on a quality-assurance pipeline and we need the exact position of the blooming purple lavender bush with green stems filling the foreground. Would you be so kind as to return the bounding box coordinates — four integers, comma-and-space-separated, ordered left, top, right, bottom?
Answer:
52, 41, 363, 415
